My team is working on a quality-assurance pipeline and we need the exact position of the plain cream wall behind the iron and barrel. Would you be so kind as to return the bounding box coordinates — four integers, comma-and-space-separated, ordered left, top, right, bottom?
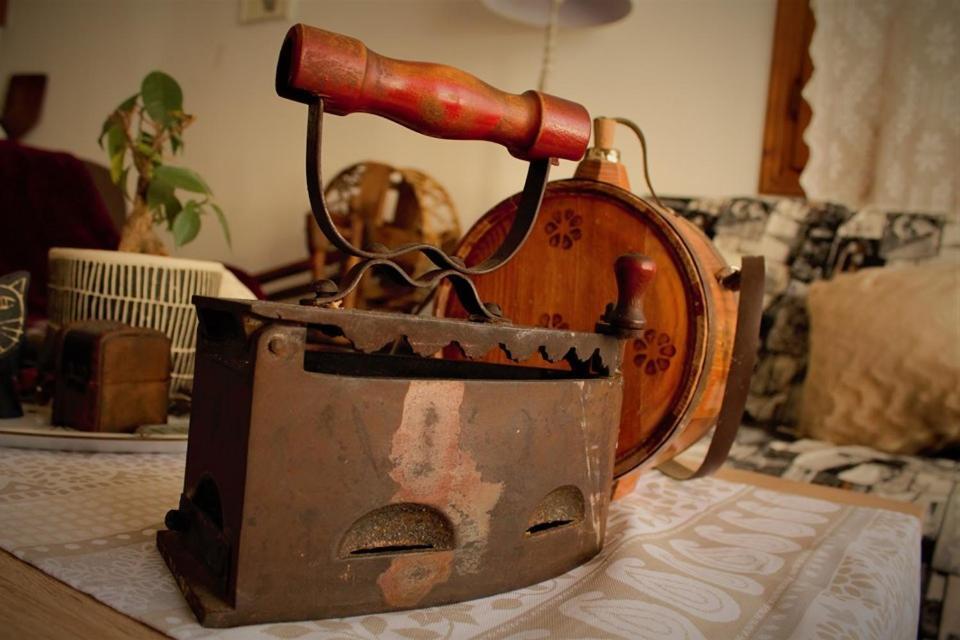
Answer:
0, 0, 775, 271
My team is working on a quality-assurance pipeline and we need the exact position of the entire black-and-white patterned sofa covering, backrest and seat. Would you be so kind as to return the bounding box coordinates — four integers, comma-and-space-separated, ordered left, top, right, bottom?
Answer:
666, 198, 960, 638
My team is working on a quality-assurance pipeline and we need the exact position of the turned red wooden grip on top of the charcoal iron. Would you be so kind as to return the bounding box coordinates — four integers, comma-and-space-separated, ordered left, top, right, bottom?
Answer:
277, 24, 590, 160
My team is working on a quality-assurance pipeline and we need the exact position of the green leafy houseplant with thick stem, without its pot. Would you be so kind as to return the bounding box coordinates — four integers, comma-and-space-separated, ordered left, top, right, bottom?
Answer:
98, 71, 230, 255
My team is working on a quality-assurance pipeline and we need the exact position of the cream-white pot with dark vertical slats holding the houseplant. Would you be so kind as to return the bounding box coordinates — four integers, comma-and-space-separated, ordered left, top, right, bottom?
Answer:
47, 247, 254, 397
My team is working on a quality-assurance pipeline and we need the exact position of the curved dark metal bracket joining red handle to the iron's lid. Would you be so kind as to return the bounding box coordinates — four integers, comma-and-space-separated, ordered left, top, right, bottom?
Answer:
301, 98, 551, 321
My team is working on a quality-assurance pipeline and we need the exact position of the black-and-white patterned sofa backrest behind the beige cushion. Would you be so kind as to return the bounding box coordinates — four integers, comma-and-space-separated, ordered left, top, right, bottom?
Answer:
664, 198, 960, 433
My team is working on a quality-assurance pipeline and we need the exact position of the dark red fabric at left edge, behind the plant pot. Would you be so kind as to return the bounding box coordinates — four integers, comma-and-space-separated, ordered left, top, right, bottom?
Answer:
0, 140, 120, 319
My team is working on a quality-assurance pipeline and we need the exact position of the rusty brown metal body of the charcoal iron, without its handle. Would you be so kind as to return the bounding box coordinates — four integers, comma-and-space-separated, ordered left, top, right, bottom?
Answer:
158, 298, 621, 626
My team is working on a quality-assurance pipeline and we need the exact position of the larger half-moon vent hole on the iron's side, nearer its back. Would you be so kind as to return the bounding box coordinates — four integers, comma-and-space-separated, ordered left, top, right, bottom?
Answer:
339, 502, 454, 558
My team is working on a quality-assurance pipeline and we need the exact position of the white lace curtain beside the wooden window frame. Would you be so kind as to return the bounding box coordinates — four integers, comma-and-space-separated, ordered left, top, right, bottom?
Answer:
800, 0, 960, 216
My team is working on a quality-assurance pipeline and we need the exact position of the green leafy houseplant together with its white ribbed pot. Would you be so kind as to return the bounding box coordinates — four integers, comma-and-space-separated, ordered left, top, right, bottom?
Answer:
48, 71, 254, 396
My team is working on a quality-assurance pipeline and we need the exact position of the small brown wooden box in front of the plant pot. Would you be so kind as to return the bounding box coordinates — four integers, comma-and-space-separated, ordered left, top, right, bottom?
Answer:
53, 320, 170, 432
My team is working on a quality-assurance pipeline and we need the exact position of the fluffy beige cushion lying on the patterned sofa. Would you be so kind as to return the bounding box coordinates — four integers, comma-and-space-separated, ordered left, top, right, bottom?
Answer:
800, 264, 960, 453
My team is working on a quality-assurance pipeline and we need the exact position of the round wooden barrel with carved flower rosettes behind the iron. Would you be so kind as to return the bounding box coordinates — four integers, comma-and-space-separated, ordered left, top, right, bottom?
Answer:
436, 179, 738, 477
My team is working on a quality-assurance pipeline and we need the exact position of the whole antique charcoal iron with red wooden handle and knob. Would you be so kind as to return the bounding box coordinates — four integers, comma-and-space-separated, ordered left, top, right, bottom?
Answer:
157, 25, 655, 627
